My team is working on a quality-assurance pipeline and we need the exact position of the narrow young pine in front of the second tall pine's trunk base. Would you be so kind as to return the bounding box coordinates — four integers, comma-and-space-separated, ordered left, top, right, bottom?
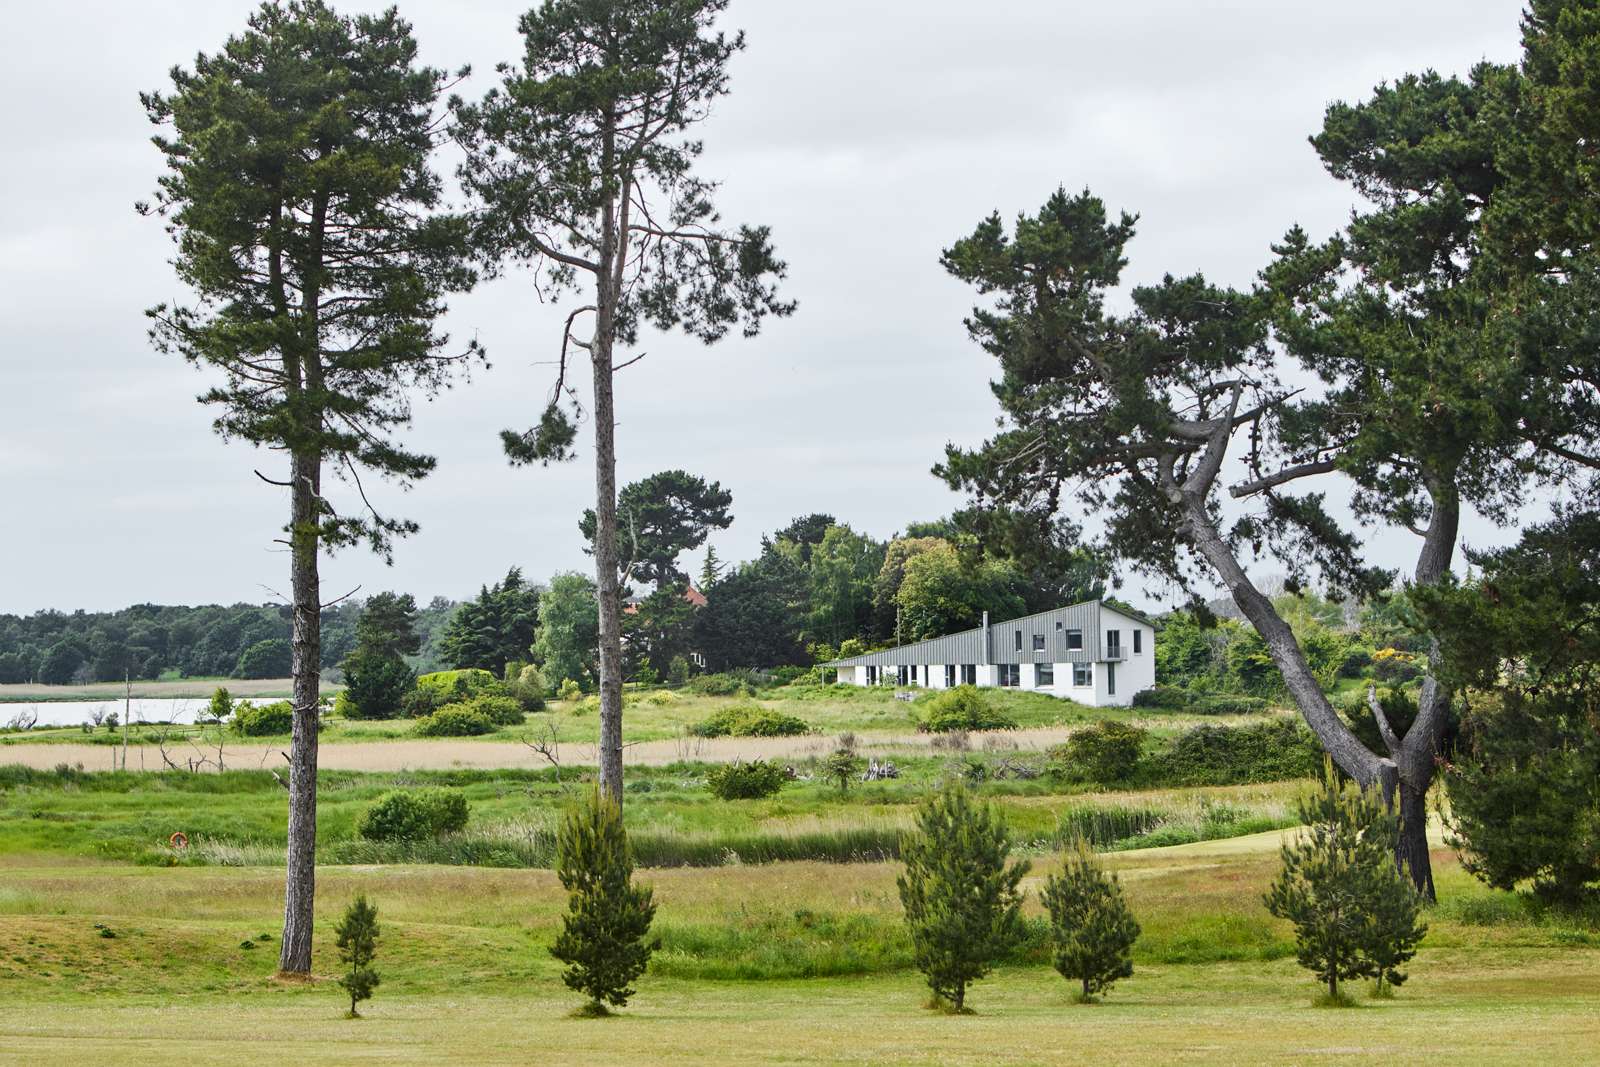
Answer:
550, 792, 661, 1016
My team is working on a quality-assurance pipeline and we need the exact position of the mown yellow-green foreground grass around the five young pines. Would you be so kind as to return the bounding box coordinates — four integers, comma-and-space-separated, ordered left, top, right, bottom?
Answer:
0, 835, 1600, 1064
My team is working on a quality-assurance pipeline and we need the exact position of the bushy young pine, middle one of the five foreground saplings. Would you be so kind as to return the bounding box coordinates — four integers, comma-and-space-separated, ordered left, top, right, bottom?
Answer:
898, 779, 1029, 1013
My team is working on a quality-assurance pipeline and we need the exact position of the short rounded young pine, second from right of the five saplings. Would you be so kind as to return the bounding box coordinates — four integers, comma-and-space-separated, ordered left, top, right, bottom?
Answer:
1043, 838, 1139, 1003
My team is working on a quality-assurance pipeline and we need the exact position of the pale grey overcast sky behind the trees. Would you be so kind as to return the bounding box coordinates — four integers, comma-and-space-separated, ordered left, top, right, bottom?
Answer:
0, 0, 1520, 613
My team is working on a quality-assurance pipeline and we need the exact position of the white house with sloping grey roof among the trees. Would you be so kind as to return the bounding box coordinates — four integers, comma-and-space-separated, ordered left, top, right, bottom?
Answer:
822, 600, 1155, 707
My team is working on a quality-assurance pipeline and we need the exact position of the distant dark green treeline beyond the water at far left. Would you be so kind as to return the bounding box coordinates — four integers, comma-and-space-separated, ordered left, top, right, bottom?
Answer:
0, 597, 458, 685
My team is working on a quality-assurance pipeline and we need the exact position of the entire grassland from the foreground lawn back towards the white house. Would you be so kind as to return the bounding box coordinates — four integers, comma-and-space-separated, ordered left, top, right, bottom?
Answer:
0, 691, 1600, 1067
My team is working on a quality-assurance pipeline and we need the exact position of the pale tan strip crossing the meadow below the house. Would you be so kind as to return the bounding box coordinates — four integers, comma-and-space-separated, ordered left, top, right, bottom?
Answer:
0, 728, 1067, 771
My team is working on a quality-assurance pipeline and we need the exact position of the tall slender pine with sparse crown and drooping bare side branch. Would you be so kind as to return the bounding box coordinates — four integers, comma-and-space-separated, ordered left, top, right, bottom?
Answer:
456, 0, 794, 801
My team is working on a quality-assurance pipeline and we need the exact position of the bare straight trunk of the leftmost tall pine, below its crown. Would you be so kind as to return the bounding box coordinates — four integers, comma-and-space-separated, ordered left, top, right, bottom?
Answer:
278, 453, 322, 974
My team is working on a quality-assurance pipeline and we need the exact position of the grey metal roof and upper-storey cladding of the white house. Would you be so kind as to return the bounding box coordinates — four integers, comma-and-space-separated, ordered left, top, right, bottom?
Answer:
824, 600, 1139, 667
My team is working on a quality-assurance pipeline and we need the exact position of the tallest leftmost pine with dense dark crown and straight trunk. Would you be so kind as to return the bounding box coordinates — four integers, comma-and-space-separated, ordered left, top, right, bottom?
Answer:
141, 0, 480, 974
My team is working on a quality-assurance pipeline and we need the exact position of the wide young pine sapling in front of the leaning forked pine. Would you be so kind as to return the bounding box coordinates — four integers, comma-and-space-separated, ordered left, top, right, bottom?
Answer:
1266, 758, 1427, 1001
